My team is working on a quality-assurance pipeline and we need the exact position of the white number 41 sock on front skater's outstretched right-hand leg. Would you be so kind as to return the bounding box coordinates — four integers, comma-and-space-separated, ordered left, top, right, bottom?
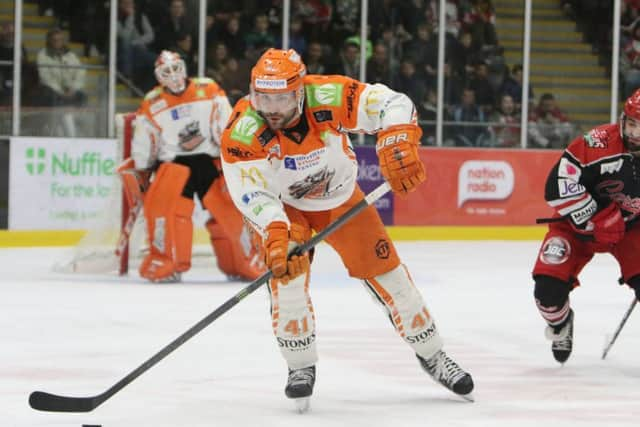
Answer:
363, 264, 442, 359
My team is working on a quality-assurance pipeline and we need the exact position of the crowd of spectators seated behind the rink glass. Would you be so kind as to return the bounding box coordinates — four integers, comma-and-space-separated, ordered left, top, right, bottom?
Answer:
0, 0, 573, 148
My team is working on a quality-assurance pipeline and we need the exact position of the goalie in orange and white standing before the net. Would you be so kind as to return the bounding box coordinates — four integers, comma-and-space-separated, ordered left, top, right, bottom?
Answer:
125, 51, 266, 282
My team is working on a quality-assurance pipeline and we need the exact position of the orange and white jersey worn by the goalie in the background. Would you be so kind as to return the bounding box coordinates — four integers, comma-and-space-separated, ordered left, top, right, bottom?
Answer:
132, 78, 231, 169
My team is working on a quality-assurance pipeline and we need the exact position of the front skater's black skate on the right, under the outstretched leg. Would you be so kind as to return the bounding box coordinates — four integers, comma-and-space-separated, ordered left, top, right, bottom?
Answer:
416, 350, 473, 402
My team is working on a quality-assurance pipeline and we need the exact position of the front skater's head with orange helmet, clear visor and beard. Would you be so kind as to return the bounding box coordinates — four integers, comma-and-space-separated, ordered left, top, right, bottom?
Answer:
250, 49, 307, 130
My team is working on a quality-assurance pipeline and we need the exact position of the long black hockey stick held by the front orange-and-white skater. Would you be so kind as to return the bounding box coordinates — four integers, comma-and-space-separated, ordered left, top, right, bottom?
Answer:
29, 182, 390, 412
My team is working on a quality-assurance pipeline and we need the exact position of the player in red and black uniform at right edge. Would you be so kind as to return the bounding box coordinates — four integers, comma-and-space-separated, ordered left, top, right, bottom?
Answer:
533, 90, 640, 363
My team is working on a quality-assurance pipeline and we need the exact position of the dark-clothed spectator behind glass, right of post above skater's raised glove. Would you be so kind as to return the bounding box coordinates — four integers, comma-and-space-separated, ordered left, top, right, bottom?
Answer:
452, 88, 488, 147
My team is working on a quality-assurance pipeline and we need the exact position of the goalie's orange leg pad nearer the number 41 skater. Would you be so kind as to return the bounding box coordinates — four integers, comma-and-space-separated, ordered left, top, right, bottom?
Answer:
202, 178, 266, 280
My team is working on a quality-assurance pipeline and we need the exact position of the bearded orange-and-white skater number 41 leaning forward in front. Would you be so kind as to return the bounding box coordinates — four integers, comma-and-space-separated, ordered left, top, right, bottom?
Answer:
222, 49, 473, 412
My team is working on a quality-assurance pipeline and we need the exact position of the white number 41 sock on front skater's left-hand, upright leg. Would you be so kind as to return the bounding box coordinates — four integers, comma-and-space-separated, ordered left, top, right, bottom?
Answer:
269, 272, 318, 369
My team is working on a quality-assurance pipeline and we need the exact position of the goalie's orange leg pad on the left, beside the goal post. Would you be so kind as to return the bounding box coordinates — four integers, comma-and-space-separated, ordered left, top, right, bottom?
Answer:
140, 163, 194, 281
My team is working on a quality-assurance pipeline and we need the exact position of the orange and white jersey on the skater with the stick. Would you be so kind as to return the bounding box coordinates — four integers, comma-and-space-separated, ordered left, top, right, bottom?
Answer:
221, 75, 417, 234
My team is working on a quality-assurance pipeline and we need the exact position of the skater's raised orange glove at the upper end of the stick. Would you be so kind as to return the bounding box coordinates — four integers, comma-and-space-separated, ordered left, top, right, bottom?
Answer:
376, 125, 427, 194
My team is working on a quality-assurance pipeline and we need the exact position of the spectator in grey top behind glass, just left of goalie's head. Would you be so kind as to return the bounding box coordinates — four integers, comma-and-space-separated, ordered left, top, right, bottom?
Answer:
117, 0, 156, 91
